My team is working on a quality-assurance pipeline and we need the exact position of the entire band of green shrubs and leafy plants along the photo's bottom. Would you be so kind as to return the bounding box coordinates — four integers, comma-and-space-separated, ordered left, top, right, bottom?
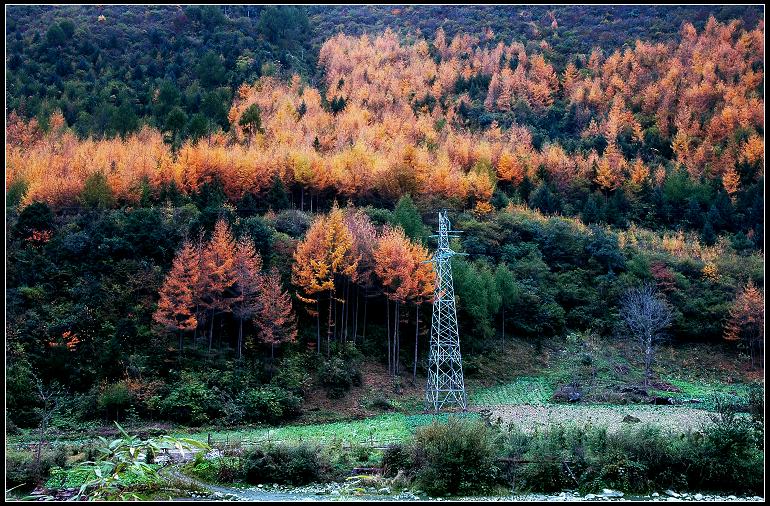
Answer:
6, 397, 764, 498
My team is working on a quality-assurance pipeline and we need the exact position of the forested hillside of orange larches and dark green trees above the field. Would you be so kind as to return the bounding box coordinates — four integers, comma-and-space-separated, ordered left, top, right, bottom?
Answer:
6, 6, 765, 440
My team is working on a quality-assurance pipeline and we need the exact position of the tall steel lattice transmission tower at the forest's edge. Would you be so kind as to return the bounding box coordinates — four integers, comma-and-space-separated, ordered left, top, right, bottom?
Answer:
425, 209, 467, 412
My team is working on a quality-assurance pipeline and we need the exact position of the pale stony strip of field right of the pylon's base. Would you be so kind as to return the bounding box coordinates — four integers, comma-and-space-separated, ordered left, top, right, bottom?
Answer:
478, 405, 711, 432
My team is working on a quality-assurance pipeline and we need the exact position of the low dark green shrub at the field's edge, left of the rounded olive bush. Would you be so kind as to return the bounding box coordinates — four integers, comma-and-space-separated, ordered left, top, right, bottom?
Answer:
244, 444, 330, 485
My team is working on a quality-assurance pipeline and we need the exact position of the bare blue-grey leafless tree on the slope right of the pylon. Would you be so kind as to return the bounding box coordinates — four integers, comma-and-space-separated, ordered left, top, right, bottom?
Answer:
620, 283, 672, 388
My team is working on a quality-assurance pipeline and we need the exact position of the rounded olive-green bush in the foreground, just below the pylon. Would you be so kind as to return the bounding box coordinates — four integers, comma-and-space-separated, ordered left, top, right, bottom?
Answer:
412, 417, 500, 494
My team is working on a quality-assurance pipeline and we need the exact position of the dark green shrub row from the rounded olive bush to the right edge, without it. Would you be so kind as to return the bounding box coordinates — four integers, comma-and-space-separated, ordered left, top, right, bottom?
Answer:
498, 420, 763, 493
